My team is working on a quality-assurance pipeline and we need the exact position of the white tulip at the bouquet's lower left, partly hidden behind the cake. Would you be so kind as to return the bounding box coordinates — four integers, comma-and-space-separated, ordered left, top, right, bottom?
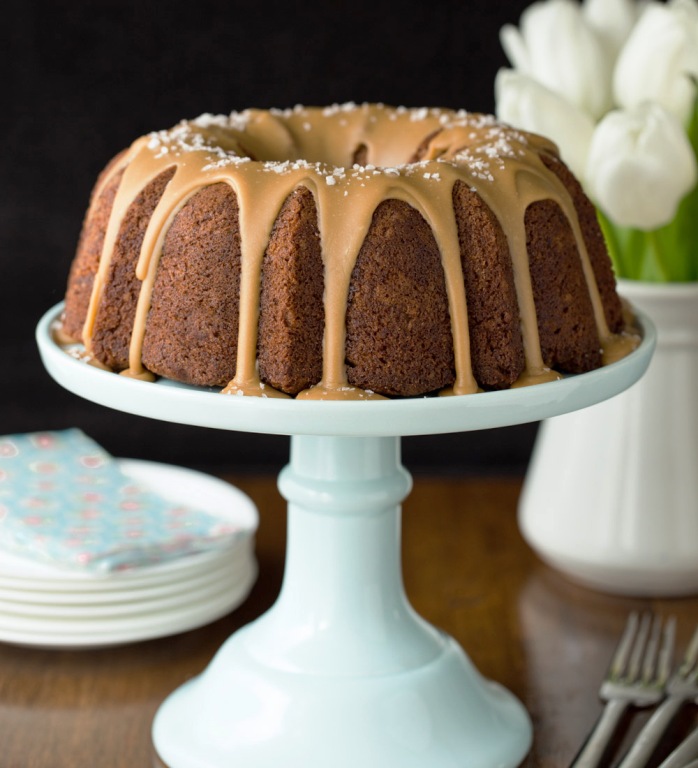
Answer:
494, 69, 594, 177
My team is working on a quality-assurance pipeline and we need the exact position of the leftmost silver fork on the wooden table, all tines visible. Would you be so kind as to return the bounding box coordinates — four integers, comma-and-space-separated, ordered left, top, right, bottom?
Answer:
571, 612, 676, 768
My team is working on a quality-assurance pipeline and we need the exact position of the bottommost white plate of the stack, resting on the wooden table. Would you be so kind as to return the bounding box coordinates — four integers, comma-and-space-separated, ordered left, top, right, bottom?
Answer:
0, 564, 257, 649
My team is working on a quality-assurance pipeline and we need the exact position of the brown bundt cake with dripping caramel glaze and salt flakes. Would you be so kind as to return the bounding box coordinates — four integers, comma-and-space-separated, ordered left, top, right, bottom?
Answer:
61, 104, 632, 399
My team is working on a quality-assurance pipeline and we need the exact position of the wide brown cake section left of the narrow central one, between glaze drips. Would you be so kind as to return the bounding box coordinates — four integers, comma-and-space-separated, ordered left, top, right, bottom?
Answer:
143, 184, 240, 386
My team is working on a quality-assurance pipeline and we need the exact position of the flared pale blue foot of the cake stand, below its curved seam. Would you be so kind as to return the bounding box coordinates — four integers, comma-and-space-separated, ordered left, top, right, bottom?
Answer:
154, 635, 520, 768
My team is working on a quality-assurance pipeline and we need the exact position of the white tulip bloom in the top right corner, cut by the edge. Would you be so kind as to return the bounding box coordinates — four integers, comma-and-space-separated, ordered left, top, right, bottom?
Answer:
613, 0, 698, 125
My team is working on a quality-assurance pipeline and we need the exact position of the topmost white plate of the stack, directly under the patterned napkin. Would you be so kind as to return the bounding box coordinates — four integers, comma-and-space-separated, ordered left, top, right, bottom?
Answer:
0, 459, 259, 592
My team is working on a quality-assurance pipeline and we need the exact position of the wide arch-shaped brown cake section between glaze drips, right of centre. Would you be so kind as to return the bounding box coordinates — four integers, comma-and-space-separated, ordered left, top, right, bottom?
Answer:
346, 195, 455, 396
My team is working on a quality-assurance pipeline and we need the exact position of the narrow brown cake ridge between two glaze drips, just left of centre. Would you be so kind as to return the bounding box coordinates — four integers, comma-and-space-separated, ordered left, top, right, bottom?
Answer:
256, 188, 325, 395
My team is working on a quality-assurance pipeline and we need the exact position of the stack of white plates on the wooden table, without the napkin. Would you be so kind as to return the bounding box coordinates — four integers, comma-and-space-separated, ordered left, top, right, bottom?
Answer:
0, 460, 258, 648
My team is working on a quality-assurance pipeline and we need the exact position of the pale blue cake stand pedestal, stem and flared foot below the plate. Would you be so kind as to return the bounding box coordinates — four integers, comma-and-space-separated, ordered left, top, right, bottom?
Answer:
153, 436, 531, 768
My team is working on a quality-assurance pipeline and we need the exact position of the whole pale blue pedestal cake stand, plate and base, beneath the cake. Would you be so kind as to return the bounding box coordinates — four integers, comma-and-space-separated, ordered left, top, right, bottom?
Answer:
37, 306, 655, 768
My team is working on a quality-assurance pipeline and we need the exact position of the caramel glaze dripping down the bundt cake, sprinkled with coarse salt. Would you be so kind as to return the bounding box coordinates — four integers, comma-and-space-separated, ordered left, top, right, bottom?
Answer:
72, 104, 637, 399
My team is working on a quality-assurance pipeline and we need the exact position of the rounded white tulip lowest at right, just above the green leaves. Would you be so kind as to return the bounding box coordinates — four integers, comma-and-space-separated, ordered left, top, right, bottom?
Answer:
585, 103, 697, 230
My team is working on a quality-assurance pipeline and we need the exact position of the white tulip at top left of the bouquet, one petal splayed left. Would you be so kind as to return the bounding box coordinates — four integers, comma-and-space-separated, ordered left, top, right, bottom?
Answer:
500, 0, 612, 118
